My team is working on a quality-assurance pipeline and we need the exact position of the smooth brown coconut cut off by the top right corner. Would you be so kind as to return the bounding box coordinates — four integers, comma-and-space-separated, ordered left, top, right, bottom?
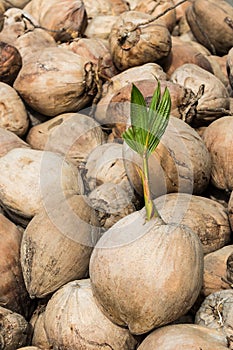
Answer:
186, 0, 233, 56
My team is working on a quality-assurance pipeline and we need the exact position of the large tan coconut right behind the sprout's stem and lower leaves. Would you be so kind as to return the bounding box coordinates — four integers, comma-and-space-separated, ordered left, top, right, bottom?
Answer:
123, 117, 211, 198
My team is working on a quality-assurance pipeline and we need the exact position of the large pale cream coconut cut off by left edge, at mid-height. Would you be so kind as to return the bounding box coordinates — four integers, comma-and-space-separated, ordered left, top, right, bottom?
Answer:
0, 148, 82, 224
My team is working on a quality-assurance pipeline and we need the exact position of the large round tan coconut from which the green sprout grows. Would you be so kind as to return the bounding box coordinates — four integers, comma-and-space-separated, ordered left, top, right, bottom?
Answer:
90, 208, 203, 334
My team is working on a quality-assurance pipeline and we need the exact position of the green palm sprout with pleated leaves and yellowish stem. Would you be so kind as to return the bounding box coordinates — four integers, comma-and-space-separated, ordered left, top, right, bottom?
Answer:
122, 81, 171, 220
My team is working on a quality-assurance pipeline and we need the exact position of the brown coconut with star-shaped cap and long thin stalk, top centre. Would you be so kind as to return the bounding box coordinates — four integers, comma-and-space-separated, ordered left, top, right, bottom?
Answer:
109, 11, 171, 71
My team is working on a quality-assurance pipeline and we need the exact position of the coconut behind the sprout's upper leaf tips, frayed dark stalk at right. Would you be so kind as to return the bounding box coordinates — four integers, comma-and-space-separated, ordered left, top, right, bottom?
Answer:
97, 79, 201, 139
